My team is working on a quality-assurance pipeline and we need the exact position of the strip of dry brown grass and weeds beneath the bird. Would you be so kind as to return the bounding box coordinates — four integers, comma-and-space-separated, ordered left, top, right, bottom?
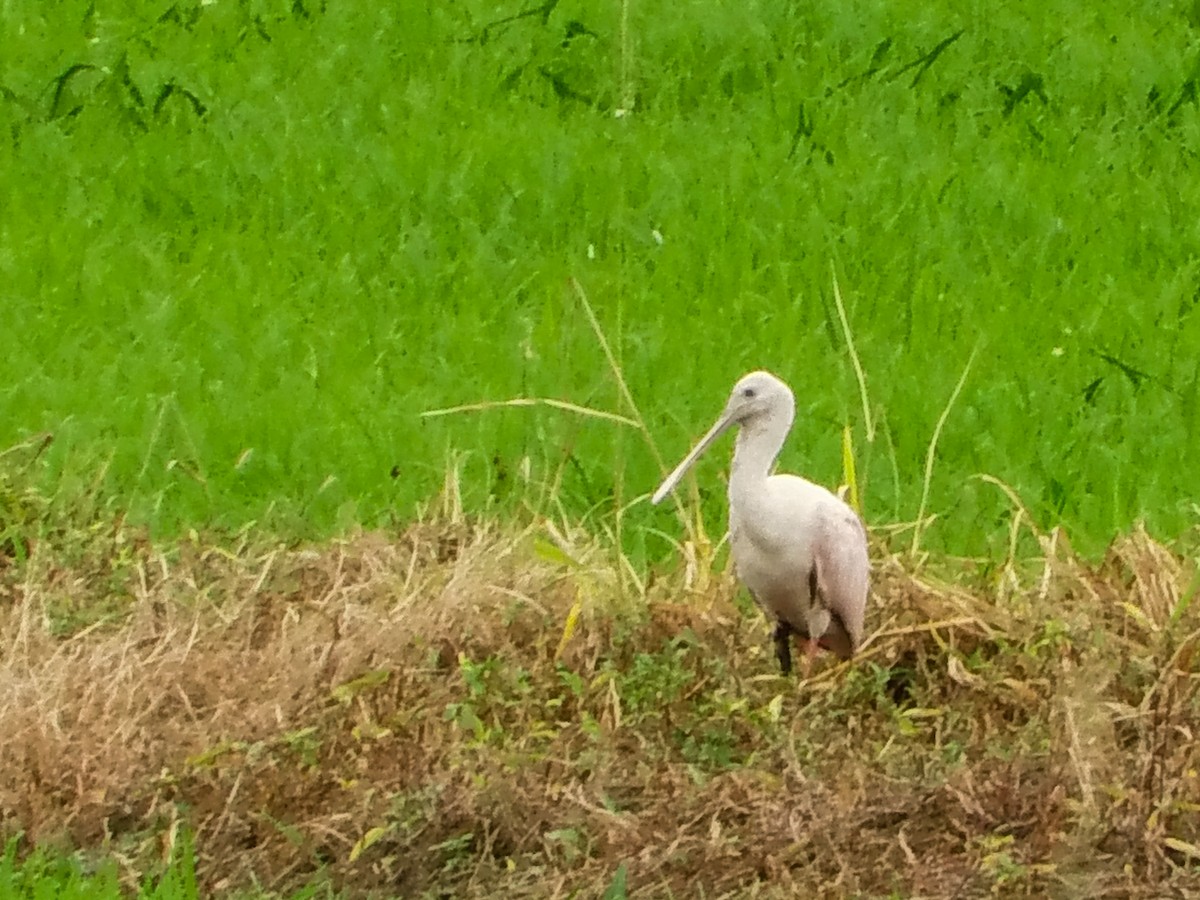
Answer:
0, 504, 1200, 898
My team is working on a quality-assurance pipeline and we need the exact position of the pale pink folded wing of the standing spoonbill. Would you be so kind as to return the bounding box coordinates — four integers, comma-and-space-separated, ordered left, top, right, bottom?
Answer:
812, 506, 871, 659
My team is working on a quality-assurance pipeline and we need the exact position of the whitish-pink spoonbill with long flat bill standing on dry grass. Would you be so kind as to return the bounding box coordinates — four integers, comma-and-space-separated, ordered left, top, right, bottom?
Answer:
652, 372, 870, 674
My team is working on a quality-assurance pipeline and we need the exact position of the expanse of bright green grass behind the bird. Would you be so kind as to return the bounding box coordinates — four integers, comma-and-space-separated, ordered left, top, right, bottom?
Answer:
0, 0, 1200, 556
